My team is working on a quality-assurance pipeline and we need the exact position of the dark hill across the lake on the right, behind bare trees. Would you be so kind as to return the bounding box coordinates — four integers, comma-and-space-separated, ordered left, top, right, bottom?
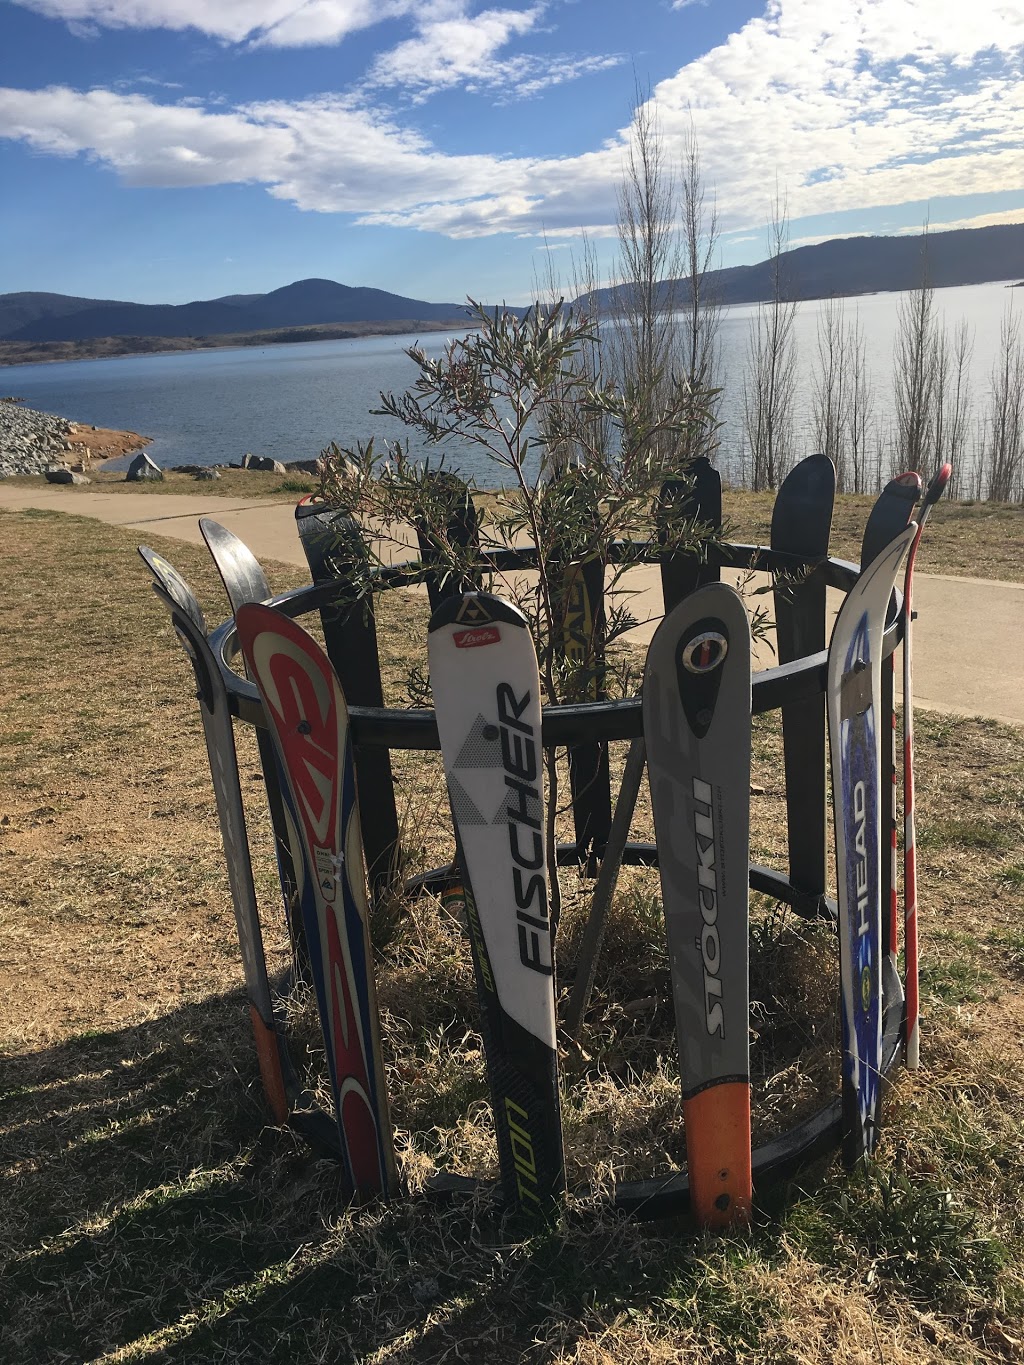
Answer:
578, 222, 1024, 308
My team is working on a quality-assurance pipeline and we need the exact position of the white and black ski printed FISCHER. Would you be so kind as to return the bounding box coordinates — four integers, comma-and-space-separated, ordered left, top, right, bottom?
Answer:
429, 592, 565, 1212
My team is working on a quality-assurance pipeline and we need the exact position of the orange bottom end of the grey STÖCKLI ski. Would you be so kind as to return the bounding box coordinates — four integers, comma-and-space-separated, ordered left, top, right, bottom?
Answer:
683, 1081, 752, 1231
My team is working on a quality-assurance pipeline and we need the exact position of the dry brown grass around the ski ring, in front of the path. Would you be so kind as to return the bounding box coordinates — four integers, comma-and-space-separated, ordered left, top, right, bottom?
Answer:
0, 507, 1024, 1365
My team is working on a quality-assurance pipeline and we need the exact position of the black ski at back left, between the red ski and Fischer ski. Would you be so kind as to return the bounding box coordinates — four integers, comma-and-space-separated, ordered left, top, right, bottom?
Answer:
295, 495, 400, 895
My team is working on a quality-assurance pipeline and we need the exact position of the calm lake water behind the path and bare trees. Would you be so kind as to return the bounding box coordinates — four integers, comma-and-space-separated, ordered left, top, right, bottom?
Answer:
0, 284, 1024, 486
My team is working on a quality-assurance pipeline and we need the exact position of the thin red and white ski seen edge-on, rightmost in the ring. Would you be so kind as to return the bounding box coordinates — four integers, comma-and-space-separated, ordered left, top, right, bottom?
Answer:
902, 464, 953, 1072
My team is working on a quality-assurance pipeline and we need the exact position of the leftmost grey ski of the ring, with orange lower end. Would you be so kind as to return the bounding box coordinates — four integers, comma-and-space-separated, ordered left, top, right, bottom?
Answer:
139, 545, 296, 1123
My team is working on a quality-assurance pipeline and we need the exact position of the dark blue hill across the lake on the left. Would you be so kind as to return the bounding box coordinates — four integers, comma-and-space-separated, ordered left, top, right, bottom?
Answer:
0, 280, 477, 341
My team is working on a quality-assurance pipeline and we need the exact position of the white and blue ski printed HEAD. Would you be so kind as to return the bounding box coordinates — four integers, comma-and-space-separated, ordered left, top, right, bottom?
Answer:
826, 523, 918, 1166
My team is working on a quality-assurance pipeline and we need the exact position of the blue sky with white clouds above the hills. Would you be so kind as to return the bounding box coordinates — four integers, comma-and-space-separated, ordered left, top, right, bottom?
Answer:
0, 0, 1024, 303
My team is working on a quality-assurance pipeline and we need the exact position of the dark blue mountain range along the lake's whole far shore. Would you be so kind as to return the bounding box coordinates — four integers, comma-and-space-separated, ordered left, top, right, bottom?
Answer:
0, 222, 1024, 349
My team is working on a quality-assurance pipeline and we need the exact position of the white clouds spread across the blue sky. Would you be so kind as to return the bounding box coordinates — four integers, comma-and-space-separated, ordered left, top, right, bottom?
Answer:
0, 0, 1024, 239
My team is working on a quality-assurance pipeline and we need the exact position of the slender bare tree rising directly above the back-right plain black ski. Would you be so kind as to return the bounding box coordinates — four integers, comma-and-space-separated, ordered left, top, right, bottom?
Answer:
743, 195, 796, 489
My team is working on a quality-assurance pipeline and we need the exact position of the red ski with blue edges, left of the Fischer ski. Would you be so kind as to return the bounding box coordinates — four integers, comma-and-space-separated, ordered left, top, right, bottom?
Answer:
236, 605, 397, 1196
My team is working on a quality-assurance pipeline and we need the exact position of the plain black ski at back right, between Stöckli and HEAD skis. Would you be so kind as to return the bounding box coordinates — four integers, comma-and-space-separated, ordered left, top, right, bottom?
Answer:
771, 455, 836, 895
